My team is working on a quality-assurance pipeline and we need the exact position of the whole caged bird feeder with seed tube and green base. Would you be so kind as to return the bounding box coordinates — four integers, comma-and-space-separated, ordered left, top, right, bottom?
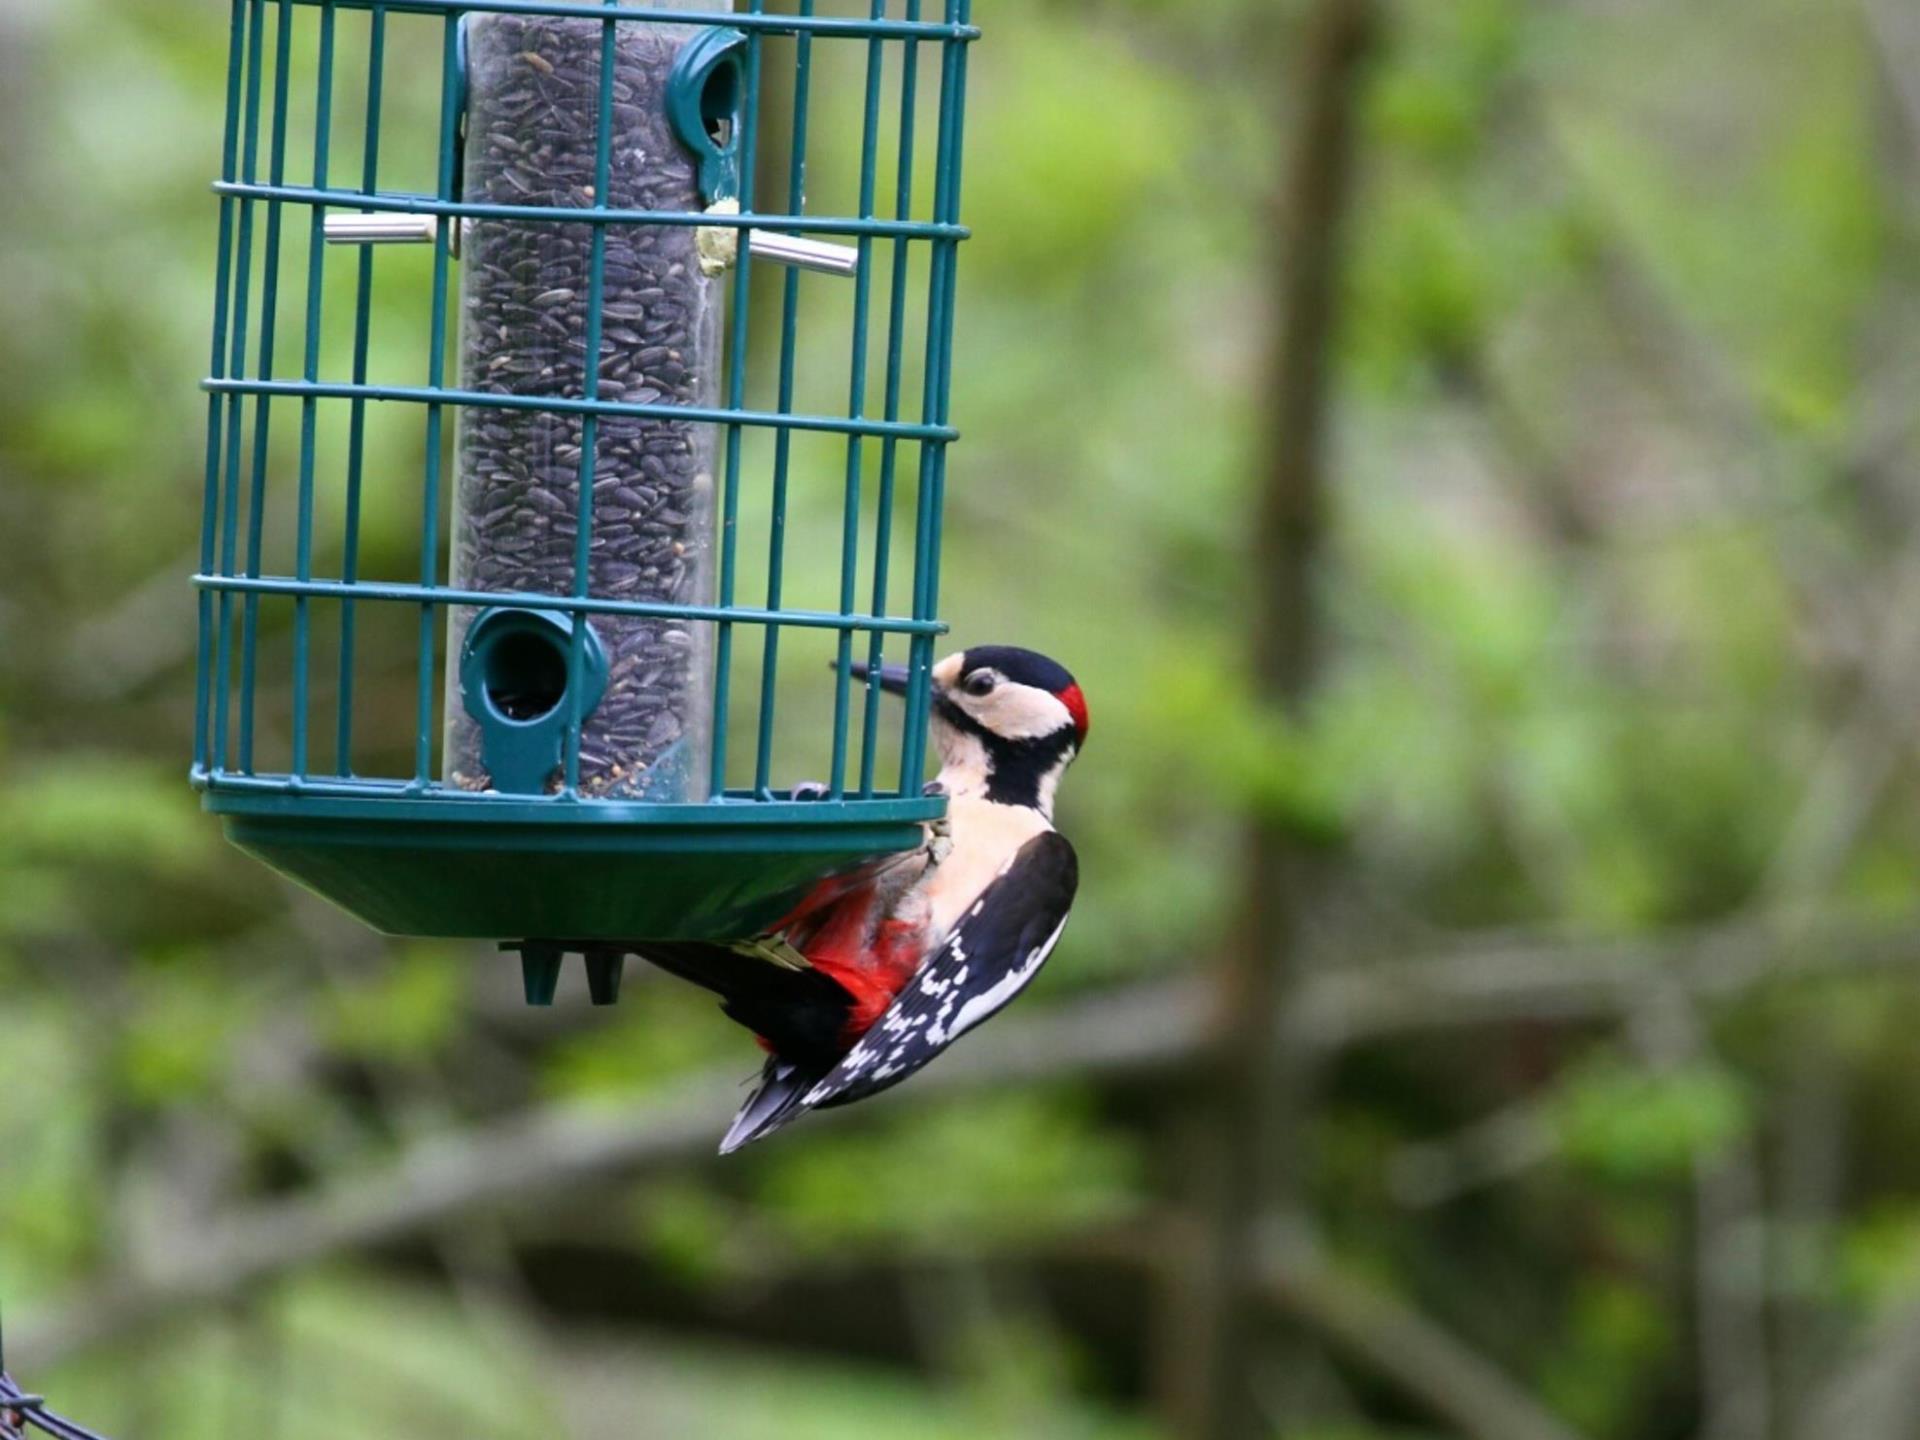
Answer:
194, 0, 975, 1000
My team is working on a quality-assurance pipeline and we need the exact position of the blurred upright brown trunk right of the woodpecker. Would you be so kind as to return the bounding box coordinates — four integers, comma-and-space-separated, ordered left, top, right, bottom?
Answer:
1162, 0, 1380, 1440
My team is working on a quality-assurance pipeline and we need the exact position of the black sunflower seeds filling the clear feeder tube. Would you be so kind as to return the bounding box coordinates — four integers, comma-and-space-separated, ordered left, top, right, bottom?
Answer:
447, 13, 720, 801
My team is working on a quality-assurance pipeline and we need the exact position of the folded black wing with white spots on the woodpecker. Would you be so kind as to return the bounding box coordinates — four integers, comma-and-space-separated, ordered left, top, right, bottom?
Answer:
804, 829, 1079, 1110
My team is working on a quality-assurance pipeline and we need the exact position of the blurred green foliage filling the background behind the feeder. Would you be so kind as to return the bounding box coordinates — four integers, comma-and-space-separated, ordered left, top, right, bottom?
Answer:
0, 0, 1920, 1440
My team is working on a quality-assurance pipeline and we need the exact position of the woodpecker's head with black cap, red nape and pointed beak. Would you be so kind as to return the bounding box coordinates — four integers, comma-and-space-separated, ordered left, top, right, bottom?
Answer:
854, 645, 1089, 818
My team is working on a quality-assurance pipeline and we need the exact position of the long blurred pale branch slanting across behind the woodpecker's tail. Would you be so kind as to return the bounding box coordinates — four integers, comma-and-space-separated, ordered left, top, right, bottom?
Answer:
8, 922, 1920, 1369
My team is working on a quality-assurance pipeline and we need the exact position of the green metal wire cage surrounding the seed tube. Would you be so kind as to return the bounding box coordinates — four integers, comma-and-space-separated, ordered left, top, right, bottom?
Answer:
194, 0, 977, 998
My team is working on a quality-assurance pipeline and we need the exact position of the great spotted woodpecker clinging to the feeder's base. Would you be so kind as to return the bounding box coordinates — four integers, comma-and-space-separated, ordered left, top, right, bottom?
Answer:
639, 645, 1087, 1154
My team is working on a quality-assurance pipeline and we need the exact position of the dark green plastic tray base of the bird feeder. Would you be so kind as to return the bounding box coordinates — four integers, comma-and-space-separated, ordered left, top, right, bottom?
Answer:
205, 787, 945, 948
